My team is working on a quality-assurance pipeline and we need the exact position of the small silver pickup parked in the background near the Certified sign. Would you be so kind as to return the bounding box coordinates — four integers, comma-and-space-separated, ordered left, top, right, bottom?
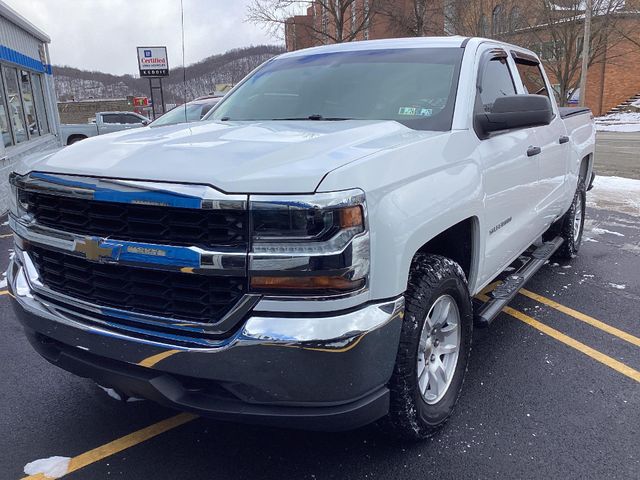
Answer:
60, 112, 150, 145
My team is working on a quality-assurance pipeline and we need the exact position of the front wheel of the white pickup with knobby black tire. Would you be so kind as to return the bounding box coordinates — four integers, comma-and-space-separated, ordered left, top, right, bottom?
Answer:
385, 253, 473, 440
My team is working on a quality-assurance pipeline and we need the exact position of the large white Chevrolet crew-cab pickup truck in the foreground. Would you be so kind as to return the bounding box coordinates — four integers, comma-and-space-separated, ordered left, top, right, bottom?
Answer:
8, 37, 594, 438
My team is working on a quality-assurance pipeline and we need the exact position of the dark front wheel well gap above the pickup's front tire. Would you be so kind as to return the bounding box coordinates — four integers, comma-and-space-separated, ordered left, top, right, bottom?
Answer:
418, 218, 475, 279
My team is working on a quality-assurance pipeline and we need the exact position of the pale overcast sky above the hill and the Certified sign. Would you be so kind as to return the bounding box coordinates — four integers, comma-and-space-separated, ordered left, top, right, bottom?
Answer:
4, 0, 283, 75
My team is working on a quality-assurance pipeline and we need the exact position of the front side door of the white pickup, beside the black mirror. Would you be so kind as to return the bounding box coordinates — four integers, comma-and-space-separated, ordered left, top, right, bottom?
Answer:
474, 49, 540, 280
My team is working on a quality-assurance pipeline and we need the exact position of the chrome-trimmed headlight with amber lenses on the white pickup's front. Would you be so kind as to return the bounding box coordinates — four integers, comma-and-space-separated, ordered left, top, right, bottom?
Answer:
249, 190, 369, 296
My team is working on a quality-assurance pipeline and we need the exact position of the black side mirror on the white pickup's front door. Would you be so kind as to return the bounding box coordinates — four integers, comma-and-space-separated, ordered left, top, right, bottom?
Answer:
475, 95, 553, 138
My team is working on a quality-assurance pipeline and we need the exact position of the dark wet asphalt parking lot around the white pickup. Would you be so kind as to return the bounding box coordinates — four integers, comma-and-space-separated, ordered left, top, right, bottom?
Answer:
0, 186, 640, 480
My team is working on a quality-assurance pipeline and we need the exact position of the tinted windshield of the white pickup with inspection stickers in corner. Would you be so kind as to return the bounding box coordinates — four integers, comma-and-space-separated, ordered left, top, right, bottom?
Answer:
207, 48, 463, 130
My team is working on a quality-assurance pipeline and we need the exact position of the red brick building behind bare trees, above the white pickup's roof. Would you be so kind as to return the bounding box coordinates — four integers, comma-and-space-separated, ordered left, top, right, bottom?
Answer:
285, 0, 640, 115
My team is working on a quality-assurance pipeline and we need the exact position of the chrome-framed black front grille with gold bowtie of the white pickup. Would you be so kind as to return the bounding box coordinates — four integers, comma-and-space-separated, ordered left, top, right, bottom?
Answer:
10, 172, 258, 344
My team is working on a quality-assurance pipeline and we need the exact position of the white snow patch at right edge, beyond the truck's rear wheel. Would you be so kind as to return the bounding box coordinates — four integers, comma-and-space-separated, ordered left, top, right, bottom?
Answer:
587, 176, 640, 216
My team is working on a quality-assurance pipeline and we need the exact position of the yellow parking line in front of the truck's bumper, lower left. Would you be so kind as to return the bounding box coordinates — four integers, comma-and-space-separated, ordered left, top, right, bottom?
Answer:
22, 413, 198, 480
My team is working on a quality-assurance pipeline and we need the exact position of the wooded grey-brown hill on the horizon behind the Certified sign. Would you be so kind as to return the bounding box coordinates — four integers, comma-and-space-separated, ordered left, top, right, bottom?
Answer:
53, 45, 284, 103
